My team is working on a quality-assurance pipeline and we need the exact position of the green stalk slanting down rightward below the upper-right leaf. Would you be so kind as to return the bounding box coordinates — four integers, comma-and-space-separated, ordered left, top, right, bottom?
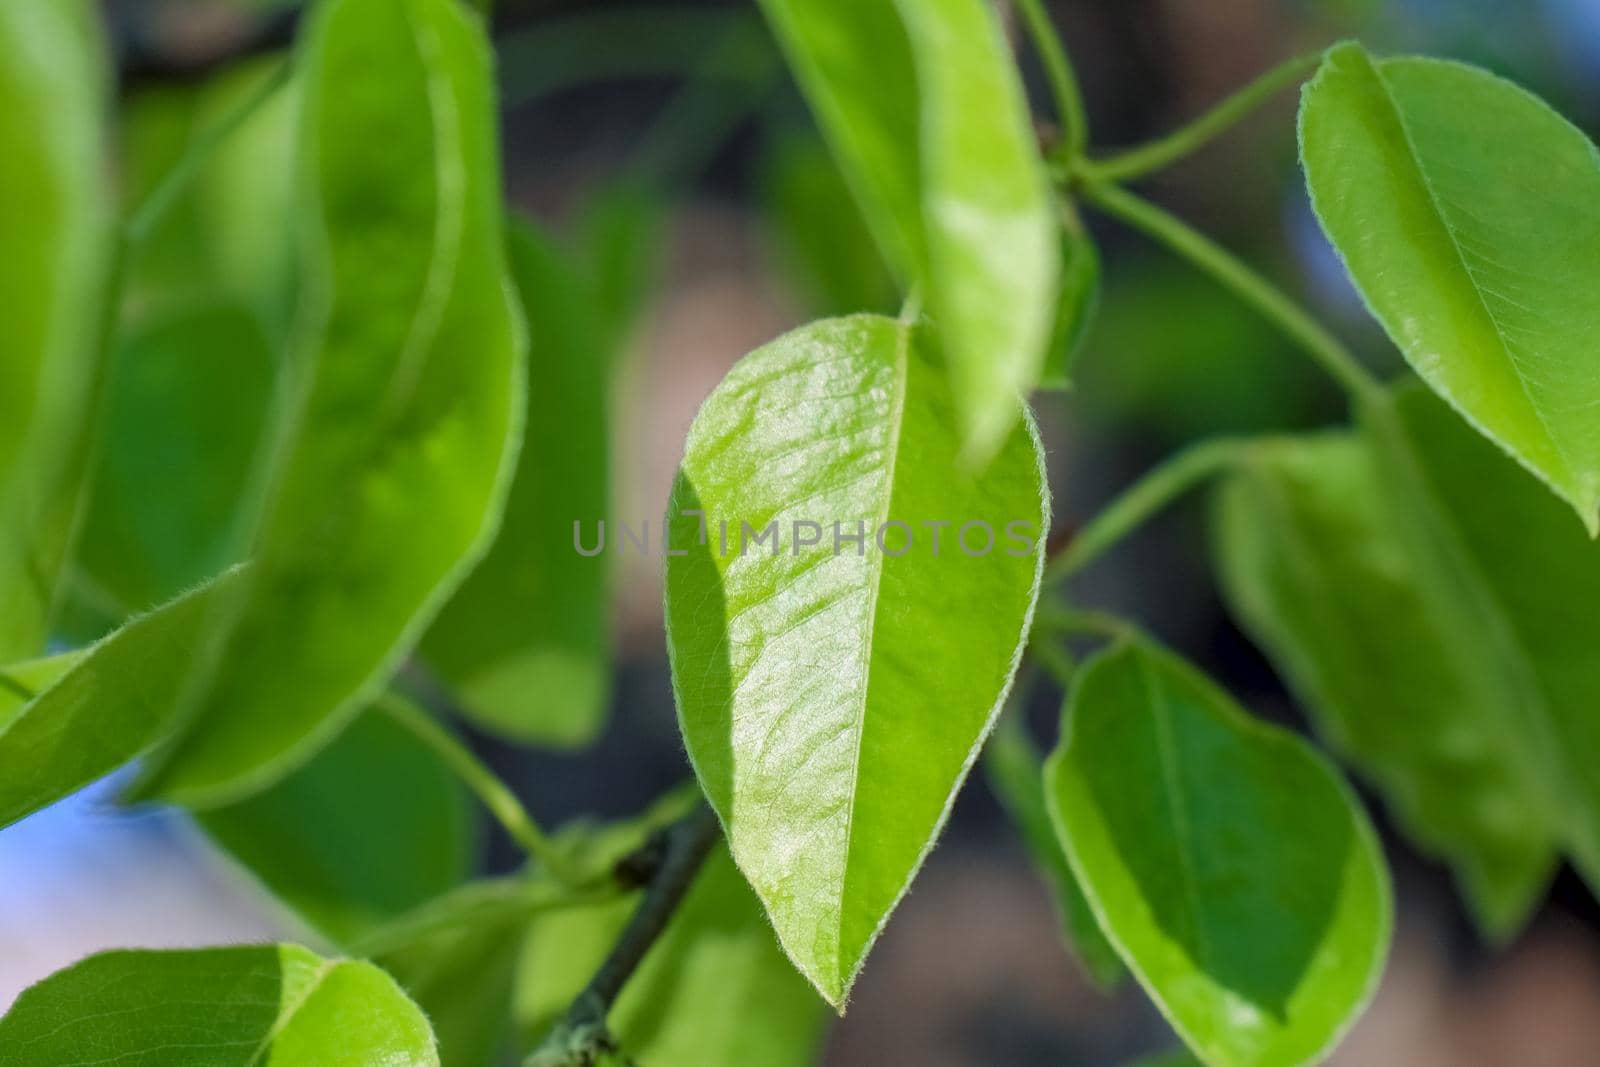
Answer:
1082, 186, 1382, 398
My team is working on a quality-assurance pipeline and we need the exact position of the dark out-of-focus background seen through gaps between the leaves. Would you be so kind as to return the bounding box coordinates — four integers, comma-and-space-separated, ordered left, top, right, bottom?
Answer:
15, 0, 1600, 1067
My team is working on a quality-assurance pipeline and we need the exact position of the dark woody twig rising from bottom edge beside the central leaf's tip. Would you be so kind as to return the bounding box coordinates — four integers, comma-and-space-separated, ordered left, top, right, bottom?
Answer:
523, 803, 722, 1067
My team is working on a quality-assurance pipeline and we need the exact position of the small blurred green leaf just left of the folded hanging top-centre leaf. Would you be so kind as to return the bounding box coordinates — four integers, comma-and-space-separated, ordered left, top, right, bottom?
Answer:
762, 136, 899, 315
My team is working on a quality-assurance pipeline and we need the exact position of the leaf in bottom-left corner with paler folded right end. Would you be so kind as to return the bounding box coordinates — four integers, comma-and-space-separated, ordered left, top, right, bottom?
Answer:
0, 945, 438, 1067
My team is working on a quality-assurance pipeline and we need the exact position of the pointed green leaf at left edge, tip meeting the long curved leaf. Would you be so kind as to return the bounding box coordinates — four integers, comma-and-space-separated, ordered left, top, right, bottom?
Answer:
0, 571, 242, 827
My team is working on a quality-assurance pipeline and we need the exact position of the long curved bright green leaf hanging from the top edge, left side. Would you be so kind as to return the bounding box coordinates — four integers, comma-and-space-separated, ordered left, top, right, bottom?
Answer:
138, 0, 525, 806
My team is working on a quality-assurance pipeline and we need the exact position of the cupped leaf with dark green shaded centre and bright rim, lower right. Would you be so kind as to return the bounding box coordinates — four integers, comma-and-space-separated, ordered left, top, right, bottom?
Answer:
1046, 641, 1392, 1067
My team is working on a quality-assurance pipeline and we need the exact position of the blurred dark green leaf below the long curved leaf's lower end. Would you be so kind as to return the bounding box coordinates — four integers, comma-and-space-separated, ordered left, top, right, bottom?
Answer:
198, 709, 477, 945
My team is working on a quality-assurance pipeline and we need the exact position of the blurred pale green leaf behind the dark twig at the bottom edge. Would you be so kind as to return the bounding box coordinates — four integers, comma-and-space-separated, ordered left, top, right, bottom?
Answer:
515, 845, 827, 1067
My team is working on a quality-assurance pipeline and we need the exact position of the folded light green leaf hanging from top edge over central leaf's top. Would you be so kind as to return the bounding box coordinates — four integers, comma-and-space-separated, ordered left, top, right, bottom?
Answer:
762, 0, 1059, 464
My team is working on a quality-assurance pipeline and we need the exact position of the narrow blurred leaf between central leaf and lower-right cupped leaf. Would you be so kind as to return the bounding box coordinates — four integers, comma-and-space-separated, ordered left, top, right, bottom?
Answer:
984, 710, 1128, 989
